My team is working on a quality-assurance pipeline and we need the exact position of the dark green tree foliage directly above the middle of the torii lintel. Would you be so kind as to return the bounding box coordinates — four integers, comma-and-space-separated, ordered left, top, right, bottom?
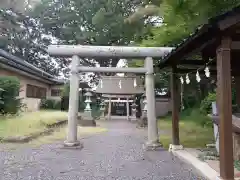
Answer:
31, 0, 151, 66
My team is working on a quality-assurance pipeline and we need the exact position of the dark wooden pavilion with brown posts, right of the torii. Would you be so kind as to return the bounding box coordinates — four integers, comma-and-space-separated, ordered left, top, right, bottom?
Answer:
159, 7, 240, 180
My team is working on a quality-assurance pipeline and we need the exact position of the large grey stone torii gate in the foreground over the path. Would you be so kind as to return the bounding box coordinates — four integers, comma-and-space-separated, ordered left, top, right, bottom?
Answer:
48, 45, 173, 149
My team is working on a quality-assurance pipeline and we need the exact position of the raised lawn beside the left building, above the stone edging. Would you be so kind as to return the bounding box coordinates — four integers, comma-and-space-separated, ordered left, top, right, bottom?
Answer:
0, 111, 67, 137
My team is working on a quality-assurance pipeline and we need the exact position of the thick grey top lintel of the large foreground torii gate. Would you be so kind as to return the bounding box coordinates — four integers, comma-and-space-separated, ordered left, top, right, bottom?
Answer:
48, 45, 173, 58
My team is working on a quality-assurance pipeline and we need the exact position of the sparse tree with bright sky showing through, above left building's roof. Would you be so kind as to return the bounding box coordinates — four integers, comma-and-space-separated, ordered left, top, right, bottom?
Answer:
0, 9, 64, 75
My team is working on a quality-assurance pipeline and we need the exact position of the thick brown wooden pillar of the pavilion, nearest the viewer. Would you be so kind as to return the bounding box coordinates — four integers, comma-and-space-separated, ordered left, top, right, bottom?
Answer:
216, 37, 234, 180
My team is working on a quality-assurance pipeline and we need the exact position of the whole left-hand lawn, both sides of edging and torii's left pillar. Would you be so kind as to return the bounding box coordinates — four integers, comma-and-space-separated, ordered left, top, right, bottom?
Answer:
0, 111, 107, 150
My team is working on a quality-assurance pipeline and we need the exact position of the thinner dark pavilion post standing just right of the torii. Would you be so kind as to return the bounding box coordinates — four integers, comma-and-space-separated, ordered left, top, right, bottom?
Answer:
171, 67, 180, 145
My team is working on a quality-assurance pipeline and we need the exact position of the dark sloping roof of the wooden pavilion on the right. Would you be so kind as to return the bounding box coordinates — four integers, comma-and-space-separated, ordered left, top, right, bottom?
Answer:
159, 6, 240, 75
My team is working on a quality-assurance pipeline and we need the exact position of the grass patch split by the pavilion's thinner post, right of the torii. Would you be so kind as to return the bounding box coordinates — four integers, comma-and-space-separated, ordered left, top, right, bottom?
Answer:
158, 110, 214, 148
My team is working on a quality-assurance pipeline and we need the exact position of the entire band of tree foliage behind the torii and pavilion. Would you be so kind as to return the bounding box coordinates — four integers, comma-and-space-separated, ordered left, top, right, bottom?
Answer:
0, 0, 240, 116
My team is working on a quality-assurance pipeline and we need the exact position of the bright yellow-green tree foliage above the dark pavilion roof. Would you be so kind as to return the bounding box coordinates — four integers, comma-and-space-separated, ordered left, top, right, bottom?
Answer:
142, 0, 240, 46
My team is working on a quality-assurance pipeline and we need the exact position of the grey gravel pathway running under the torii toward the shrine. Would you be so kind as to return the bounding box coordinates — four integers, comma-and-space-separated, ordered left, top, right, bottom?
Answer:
0, 120, 204, 180
